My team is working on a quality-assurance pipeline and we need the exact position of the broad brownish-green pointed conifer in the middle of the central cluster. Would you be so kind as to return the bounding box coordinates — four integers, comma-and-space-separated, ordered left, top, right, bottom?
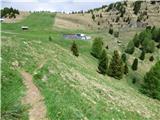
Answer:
108, 51, 124, 79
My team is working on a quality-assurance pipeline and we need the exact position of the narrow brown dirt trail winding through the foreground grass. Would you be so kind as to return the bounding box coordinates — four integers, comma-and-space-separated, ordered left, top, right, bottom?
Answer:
21, 71, 48, 120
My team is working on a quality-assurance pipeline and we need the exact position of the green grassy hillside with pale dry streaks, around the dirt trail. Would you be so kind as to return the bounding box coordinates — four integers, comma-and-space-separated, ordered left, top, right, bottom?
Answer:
2, 13, 160, 120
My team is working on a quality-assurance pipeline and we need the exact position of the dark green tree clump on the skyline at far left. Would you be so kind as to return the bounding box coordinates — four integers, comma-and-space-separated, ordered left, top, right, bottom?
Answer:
1, 7, 19, 18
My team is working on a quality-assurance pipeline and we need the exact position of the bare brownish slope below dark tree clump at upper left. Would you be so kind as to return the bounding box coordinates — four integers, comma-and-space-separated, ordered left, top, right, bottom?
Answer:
4, 12, 30, 23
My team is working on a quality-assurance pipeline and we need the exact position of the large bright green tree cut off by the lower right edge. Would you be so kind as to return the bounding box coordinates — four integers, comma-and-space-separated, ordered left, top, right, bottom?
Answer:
142, 61, 160, 100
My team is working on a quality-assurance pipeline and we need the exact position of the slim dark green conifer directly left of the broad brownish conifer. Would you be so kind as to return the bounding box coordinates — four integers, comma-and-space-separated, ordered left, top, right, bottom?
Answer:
98, 50, 108, 75
